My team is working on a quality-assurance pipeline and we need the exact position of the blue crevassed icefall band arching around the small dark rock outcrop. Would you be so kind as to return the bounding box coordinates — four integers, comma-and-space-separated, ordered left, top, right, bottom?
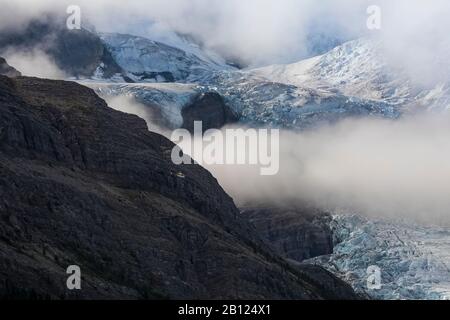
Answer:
82, 72, 399, 129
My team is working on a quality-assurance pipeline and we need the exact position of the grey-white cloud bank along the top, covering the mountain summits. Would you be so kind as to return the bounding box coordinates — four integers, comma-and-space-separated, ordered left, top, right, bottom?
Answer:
0, 0, 450, 69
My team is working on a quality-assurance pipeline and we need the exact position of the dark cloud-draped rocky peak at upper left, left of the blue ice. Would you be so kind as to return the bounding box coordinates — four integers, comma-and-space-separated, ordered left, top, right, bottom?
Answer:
0, 16, 122, 78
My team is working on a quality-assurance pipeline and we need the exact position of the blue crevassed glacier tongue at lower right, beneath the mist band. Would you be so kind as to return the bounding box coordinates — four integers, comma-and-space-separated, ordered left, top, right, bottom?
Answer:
307, 215, 450, 299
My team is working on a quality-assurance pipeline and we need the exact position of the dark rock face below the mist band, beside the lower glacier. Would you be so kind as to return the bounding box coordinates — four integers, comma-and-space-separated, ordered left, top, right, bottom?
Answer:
242, 207, 333, 262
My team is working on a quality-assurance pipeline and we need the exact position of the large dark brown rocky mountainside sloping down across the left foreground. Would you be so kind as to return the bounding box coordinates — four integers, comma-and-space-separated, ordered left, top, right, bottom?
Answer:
0, 76, 357, 299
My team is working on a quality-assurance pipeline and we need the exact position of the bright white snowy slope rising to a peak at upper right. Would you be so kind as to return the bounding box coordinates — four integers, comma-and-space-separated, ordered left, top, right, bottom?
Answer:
252, 38, 450, 109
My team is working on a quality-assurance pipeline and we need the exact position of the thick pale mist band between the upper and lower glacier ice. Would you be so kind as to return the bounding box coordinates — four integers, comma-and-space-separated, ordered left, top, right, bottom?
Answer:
200, 115, 450, 223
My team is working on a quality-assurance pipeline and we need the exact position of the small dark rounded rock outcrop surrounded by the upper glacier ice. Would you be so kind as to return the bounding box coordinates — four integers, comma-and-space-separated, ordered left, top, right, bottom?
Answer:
181, 92, 238, 132
